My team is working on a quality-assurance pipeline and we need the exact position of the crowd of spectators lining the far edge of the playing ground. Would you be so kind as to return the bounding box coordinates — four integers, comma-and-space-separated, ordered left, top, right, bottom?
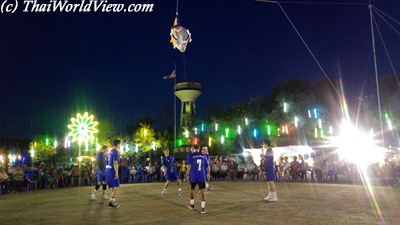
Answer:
0, 155, 400, 194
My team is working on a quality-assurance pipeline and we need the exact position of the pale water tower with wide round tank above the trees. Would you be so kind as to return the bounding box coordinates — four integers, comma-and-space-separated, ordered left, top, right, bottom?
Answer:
174, 81, 201, 126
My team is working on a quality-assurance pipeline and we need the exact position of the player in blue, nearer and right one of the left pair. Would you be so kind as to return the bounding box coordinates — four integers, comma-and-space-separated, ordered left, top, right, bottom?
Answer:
106, 140, 121, 208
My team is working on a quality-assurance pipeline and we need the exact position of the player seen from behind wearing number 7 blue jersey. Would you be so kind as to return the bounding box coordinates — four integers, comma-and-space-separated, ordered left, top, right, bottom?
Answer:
187, 146, 210, 213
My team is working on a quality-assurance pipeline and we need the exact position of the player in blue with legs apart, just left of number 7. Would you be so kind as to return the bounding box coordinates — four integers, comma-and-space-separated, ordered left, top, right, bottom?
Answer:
161, 149, 182, 196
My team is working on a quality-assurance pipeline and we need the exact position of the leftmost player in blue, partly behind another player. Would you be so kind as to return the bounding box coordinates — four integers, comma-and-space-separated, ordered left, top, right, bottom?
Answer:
92, 145, 108, 199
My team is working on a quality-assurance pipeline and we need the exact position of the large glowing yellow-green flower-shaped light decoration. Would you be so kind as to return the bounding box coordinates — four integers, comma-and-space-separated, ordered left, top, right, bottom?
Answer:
68, 112, 99, 145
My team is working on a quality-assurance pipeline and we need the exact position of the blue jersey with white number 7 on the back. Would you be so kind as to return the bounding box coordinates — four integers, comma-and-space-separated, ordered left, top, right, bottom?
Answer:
187, 152, 209, 182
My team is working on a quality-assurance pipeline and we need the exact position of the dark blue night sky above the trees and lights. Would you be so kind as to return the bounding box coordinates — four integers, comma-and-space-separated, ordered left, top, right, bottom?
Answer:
0, 0, 400, 138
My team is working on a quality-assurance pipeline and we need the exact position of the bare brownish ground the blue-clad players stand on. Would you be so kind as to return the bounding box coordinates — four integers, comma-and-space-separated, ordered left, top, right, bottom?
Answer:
0, 181, 400, 225
